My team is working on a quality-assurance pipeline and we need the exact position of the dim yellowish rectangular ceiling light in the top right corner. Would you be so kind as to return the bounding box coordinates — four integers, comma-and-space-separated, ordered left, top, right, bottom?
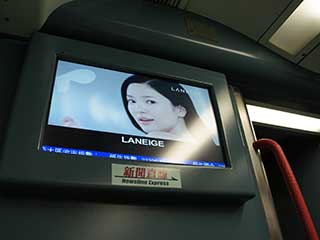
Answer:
269, 0, 320, 55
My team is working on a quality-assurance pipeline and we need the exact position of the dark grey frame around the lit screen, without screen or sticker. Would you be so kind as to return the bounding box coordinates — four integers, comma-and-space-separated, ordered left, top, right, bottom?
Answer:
0, 33, 254, 201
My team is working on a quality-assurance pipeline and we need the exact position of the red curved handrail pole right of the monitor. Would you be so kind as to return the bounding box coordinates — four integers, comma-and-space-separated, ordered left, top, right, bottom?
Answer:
253, 139, 319, 240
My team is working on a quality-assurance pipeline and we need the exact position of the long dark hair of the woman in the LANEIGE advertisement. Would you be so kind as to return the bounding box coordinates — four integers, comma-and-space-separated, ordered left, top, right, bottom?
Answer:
121, 75, 207, 137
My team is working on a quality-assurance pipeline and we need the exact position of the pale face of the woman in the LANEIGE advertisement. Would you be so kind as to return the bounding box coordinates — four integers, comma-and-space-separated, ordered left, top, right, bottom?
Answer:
127, 83, 183, 133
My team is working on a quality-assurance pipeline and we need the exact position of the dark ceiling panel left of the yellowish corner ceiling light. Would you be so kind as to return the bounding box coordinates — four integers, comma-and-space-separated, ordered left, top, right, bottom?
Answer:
186, 0, 291, 40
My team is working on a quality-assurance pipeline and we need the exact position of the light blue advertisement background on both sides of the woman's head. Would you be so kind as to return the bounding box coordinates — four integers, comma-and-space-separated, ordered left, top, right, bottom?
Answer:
48, 60, 220, 145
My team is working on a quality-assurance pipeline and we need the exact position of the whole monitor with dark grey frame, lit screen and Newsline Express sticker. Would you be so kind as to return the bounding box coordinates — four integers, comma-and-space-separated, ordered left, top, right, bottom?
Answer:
0, 33, 254, 202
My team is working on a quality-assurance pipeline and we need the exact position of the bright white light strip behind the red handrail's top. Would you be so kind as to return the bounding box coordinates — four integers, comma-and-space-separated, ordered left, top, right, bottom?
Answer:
247, 105, 320, 133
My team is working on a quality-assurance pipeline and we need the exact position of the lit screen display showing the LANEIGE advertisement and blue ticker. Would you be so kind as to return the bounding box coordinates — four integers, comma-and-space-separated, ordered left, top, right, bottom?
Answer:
40, 60, 226, 168
